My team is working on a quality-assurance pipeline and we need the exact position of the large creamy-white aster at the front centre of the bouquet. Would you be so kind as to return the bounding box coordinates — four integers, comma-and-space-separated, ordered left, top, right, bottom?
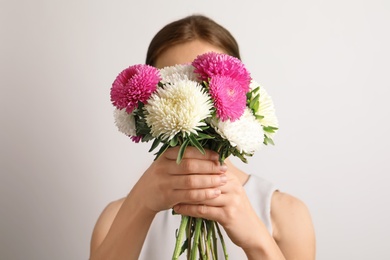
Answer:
144, 80, 212, 140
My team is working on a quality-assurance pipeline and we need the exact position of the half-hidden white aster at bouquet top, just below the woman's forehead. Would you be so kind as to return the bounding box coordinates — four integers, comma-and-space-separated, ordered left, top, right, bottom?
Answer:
160, 64, 197, 84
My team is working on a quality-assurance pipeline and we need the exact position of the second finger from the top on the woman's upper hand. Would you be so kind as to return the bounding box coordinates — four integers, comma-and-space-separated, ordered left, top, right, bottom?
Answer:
172, 174, 227, 189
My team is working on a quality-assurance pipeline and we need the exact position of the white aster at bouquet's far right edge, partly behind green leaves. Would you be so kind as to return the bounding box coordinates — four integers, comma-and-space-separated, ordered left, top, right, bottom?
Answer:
250, 81, 279, 138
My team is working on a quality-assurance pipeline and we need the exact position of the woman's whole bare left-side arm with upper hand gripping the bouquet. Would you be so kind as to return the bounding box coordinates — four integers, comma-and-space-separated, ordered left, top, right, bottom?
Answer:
90, 147, 226, 260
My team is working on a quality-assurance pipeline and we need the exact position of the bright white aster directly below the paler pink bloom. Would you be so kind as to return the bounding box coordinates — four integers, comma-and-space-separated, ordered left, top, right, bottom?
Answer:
211, 108, 264, 154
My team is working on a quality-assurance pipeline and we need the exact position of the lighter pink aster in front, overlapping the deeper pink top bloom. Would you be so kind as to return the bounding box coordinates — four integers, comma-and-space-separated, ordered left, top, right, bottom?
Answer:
209, 76, 246, 121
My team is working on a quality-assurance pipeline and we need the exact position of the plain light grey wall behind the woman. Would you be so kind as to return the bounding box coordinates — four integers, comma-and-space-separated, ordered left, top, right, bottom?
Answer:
0, 0, 390, 260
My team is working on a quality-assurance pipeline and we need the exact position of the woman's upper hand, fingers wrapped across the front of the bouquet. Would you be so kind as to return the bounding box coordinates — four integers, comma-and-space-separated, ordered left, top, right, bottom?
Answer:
131, 147, 227, 213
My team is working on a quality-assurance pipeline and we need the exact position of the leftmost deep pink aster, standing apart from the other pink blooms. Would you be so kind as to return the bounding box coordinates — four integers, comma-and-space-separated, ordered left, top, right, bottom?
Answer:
111, 64, 160, 113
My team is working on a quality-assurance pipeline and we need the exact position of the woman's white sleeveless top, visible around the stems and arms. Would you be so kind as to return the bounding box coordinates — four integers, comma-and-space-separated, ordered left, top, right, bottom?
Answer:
139, 175, 276, 260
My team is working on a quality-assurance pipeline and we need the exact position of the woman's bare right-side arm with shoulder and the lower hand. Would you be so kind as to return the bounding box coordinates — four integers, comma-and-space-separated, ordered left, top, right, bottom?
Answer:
174, 161, 315, 260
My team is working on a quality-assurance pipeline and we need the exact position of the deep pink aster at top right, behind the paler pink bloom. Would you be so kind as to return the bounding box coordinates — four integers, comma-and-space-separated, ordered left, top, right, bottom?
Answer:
192, 52, 251, 92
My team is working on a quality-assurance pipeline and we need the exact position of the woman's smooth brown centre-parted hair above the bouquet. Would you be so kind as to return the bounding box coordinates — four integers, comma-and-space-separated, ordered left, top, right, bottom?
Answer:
146, 15, 240, 66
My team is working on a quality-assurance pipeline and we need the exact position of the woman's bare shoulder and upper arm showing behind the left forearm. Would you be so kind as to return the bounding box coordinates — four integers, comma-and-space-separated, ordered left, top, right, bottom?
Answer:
91, 198, 125, 251
